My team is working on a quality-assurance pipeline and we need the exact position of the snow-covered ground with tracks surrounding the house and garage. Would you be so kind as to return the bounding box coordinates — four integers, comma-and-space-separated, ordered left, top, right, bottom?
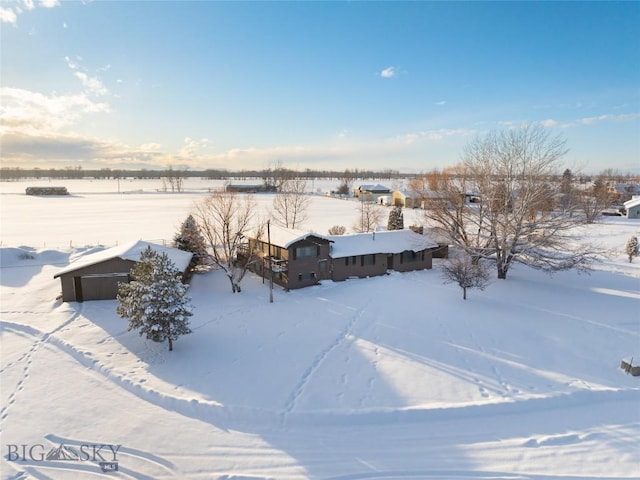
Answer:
0, 181, 640, 480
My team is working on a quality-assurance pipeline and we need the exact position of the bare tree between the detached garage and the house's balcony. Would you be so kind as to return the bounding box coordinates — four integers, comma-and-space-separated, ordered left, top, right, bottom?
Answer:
194, 192, 258, 293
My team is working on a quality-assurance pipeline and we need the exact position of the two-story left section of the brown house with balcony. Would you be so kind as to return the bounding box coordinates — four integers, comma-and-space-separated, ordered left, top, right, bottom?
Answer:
249, 224, 331, 290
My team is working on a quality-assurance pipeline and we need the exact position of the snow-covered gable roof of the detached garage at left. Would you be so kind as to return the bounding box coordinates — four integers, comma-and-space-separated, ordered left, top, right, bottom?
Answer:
53, 240, 193, 278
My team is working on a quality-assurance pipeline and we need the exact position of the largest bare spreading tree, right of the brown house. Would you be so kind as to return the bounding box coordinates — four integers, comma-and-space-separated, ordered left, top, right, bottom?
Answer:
426, 125, 601, 279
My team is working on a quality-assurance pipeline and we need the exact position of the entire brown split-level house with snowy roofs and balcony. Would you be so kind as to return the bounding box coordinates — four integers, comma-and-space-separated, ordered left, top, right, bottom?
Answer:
249, 225, 439, 289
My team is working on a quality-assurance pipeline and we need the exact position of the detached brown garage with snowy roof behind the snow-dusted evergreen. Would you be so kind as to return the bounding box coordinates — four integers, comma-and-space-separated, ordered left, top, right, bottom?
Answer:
53, 240, 193, 302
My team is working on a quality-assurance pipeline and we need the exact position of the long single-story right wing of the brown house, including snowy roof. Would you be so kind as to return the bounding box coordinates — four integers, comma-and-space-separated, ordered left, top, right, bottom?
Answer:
329, 230, 438, 281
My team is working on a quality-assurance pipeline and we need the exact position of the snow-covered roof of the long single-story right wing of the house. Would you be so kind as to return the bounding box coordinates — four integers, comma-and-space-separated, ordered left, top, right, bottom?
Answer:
329, 230, 438, 258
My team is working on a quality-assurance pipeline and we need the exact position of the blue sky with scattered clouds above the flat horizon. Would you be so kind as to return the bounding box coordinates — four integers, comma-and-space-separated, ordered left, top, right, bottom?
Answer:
0, 0, 640, 172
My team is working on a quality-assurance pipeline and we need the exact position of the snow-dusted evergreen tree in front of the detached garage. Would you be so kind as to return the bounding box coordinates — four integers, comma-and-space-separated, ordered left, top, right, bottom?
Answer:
117, 247, 192, 351
